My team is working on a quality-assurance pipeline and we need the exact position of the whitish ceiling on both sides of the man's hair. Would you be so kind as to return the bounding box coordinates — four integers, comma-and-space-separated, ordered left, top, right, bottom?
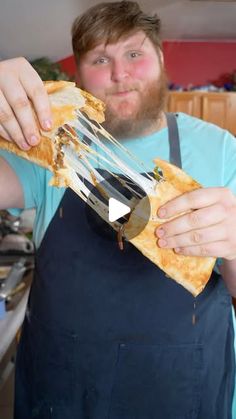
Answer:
0, 0, 236, 60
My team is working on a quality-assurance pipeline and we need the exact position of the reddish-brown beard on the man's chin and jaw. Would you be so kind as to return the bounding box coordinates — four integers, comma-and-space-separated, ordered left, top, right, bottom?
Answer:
102, 70, 167, 140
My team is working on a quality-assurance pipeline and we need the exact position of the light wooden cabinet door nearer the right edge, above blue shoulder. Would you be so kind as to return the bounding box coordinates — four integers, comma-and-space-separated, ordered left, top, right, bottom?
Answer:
202, 92, 230, 129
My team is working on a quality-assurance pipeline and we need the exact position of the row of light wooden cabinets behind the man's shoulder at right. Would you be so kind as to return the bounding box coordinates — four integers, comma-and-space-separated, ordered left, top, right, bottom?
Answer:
167, 91, 236, 135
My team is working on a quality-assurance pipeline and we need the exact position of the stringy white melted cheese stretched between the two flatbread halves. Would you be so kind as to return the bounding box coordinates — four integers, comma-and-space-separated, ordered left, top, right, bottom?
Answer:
60, 111, 161, 209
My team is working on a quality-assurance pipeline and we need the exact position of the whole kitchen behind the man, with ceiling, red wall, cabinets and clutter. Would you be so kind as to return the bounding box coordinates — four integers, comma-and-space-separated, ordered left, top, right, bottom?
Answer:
0, 0, 236, 419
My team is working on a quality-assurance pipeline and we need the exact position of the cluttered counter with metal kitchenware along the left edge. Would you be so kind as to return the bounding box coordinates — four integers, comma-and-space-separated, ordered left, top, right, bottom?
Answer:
0, 211, 34, 419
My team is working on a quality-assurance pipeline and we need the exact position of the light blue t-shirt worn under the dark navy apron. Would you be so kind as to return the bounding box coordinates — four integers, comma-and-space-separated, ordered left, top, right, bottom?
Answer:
0, 113, 236, 247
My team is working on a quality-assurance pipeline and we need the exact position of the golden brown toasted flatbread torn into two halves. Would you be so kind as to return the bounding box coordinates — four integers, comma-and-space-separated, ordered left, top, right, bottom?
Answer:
0, 81, 215, 296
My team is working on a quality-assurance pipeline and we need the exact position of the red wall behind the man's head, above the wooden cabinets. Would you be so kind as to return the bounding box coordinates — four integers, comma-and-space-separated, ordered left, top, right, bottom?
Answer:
60, 40, 236, 87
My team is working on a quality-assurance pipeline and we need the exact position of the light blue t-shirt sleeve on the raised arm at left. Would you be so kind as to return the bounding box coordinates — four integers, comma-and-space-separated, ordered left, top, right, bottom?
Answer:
0, 150, 45, 215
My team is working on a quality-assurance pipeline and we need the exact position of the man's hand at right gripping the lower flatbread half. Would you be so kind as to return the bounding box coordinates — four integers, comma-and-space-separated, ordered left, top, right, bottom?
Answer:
155, 188, 236, 260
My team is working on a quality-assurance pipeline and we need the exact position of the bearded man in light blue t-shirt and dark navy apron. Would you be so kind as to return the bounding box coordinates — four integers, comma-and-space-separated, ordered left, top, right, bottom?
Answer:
0, 1, 236, 419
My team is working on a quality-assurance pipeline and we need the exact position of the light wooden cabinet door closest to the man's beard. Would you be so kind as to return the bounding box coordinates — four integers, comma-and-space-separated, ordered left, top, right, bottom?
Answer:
168, 92, 201, 118
